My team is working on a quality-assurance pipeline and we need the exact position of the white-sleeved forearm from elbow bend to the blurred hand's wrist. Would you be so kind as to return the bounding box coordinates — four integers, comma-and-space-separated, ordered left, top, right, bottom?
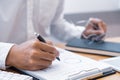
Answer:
51, 19, 85, 41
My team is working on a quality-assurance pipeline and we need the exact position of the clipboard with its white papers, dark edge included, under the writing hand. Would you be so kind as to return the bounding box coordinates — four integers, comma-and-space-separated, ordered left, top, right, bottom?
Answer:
21, 48, 114, 80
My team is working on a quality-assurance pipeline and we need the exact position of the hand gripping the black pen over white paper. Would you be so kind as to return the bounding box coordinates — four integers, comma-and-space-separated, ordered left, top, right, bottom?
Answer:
6, 39, 59, 70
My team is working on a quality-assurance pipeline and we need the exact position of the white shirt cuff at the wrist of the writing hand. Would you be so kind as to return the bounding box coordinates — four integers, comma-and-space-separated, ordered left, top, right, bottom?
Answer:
0, 42, 14, 70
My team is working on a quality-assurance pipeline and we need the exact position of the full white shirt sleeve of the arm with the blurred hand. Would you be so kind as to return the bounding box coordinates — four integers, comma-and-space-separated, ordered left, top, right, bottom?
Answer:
51, 0, 85, 42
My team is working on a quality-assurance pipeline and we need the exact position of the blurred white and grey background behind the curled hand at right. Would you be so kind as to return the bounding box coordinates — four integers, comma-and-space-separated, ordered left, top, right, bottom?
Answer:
64, 0, 120, 37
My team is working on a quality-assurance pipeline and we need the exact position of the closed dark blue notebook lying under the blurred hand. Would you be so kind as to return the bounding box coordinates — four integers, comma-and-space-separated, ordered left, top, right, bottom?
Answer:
66, 38, 120, 56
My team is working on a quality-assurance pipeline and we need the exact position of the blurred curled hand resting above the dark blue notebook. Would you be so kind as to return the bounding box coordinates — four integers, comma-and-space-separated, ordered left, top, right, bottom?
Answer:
79, 18, 106, 42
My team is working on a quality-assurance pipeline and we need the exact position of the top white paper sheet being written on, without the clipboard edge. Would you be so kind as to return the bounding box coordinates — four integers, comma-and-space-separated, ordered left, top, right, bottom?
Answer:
22, 48, 108, 80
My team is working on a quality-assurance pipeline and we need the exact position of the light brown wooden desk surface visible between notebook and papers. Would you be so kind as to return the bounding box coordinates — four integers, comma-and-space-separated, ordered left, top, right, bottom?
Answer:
8, 37, 120, 80
